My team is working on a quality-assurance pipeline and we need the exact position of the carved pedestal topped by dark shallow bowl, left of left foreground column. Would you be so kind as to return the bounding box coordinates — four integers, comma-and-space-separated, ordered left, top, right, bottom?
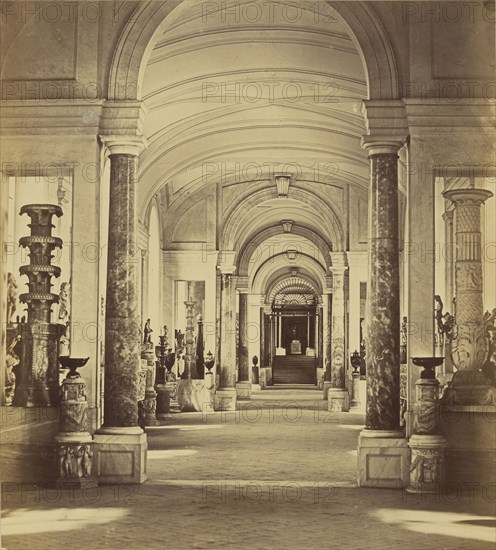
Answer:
55, 356, 98, 488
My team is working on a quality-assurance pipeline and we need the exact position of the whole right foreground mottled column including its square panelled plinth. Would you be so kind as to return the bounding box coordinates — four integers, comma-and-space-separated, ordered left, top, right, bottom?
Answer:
358, 142, 409, 487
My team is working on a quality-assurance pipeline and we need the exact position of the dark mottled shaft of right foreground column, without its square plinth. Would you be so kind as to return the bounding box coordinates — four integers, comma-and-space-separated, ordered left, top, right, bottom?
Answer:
366, 147, 400, 431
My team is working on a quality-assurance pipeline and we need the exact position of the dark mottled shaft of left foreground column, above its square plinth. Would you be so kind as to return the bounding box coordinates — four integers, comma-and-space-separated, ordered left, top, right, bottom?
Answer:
104, 154, 141, 428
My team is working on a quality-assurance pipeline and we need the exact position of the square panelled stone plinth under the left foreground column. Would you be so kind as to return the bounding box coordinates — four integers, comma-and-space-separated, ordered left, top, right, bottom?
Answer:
94, 427, 148, 485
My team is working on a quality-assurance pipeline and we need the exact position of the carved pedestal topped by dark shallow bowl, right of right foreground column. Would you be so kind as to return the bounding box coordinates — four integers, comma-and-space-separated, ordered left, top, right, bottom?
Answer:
406, 357, 447, 493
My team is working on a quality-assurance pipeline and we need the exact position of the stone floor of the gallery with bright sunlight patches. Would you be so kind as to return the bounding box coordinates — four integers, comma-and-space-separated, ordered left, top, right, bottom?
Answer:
1, 386, 496, 550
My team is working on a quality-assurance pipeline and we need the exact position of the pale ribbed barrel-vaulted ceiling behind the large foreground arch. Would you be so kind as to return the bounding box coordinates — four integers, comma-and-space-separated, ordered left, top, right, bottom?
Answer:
139, 0, 368, 220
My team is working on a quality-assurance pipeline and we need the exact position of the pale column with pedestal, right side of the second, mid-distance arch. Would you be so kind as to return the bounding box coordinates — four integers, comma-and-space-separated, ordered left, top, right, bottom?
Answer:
327, 253, 350, 411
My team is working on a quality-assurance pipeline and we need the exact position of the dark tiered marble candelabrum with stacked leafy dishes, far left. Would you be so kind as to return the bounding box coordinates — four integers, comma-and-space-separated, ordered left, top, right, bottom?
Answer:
13, 204, 62, 407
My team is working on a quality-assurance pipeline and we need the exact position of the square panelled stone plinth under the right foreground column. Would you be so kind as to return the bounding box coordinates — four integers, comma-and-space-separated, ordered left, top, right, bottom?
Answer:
357, 429, 410, 489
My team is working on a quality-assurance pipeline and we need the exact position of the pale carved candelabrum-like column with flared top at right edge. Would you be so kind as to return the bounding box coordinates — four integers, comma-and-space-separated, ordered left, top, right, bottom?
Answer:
443, 187, 496, 405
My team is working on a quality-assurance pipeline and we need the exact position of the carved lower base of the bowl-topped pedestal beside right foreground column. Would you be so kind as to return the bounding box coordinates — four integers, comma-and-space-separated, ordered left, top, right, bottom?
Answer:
406, 434, 448, 493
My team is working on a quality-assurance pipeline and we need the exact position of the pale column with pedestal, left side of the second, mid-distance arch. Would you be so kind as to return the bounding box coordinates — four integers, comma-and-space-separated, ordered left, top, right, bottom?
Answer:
215, 268, 236, 411
